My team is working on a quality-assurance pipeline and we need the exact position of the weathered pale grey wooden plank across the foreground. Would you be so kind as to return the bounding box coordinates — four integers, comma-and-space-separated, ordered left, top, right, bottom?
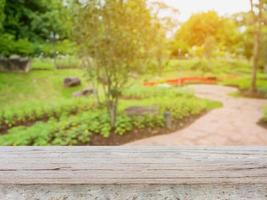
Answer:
0, 147, 267, 185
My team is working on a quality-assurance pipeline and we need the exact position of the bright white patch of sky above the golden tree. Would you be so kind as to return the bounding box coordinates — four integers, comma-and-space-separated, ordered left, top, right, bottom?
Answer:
161, 0, 249, 21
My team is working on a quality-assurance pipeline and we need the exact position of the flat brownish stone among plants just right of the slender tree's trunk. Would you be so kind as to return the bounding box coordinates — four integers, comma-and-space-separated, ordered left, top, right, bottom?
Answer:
124, 106, 159, 116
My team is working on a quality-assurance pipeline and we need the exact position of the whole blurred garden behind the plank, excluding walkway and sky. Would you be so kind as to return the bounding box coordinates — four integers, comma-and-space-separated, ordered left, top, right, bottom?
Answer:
0, 0, 267, 146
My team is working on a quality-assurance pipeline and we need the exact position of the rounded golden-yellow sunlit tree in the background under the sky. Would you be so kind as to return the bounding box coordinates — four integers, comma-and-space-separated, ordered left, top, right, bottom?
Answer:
174, 11, 242, 56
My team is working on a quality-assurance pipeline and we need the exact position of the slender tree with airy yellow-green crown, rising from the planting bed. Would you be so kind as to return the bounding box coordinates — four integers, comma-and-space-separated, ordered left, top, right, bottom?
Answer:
74, 0, 155, 127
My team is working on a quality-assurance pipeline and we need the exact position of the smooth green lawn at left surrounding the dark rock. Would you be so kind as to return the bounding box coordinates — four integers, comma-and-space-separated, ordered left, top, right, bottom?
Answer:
0, 69, 86, 110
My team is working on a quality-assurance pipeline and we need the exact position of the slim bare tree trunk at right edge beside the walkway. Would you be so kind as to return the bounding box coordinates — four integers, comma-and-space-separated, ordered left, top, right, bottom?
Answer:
250, 0, 266, 93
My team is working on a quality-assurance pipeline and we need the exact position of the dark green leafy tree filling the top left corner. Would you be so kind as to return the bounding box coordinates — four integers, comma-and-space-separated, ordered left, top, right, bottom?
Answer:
0, 0, 71, 56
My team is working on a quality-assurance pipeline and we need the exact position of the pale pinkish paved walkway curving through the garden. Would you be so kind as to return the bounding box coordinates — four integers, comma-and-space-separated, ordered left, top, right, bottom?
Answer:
128, 85, 267, 146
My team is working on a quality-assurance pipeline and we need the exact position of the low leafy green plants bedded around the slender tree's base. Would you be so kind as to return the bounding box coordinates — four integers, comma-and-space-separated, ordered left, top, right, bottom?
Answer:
0, 88, 220, 146
